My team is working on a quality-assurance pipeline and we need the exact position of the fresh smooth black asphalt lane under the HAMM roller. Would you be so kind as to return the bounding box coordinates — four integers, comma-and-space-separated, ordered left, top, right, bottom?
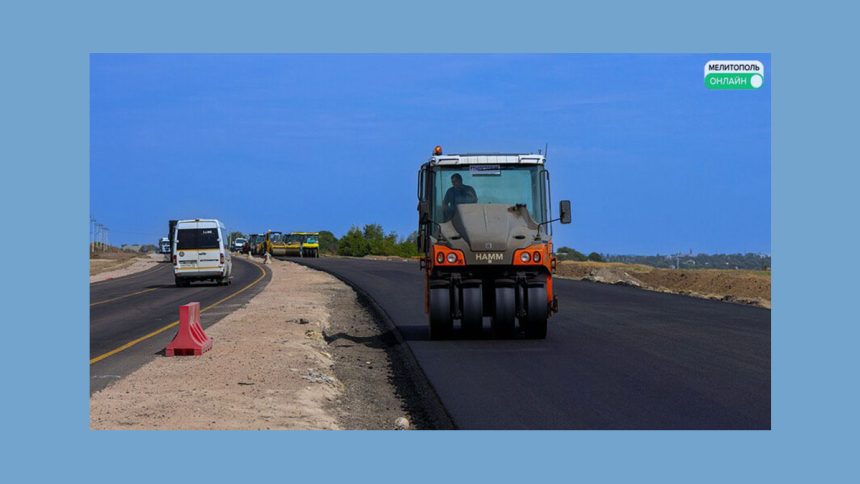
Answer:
291, 258, 771, 429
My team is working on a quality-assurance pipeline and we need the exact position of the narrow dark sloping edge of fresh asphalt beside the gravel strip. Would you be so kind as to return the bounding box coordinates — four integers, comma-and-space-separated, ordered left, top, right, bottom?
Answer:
288, 259, 457, 430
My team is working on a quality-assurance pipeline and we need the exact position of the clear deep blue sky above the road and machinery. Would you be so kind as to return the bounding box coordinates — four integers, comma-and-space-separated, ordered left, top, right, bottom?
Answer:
90, 54, 771, 254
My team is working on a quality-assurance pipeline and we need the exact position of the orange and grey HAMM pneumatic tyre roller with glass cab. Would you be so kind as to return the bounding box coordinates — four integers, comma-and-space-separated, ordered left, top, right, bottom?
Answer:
417, 146, 571, 339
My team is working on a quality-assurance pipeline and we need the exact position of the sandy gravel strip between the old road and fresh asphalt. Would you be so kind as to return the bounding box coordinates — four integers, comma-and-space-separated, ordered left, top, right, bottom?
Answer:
90, 255, 421, 430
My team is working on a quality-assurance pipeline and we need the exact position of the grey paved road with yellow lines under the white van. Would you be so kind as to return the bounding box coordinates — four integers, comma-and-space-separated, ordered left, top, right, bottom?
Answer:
90, 255, 271, 393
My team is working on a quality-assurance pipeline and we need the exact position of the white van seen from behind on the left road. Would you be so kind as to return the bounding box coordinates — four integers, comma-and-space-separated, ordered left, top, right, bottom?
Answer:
173, 218, 233, 286
